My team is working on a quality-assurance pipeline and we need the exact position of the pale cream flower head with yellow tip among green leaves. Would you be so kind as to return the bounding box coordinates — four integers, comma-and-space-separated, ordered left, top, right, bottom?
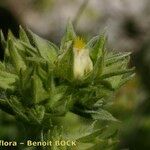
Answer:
73, 37, 93, 79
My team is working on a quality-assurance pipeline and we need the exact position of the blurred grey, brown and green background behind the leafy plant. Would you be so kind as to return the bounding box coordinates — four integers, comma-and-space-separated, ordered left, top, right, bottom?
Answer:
0, 0, 150, 150
